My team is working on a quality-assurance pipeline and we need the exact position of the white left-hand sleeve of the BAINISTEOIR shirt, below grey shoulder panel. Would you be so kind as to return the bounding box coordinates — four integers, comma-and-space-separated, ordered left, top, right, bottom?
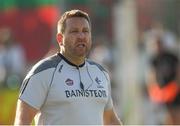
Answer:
19, 69, 53, 110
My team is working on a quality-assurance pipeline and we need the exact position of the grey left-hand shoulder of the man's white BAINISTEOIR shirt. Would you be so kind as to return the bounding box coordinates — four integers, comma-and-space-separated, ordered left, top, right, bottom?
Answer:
30, 54, 61, 74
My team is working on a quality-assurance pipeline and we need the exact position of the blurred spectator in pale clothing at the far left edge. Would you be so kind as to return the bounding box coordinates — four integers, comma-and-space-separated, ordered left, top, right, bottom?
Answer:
0, 28, 26, 89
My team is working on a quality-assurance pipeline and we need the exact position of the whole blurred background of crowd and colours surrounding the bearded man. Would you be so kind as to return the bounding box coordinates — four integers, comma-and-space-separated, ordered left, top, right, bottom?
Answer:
0, 0, 180, 125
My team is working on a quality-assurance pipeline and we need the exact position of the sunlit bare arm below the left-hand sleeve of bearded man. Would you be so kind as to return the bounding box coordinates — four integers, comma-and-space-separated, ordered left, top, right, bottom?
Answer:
14, 100, 38, 125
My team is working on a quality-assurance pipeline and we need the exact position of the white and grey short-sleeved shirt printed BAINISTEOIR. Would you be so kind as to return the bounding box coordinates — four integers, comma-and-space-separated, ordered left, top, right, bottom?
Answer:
19, 53, 113, 125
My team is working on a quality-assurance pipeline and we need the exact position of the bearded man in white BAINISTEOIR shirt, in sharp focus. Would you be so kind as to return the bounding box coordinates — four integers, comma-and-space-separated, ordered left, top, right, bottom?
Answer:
15, 10, 120, 125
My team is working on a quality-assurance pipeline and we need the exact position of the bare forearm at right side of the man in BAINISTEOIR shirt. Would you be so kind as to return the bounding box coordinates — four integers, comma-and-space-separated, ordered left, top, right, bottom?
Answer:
104, 109, 122, 125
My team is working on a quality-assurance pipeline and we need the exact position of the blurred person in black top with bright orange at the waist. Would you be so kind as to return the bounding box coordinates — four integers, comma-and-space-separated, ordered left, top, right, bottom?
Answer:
148, 36, 180, 125
